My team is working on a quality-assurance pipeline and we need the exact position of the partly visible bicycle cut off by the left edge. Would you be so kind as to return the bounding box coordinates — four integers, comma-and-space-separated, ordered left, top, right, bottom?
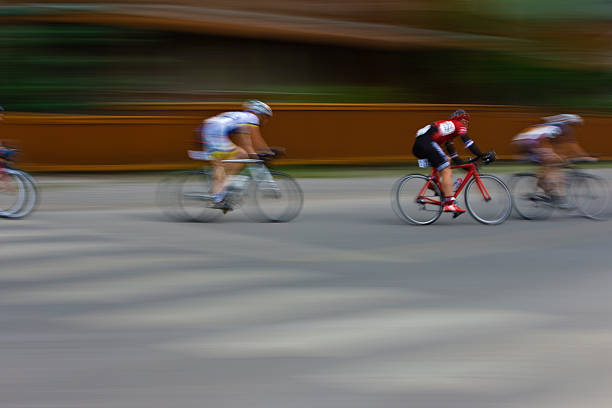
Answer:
0, 147, 39, 219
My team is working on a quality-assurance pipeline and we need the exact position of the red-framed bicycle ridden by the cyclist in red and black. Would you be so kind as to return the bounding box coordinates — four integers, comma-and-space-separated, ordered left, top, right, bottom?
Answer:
391, 152, 512, 225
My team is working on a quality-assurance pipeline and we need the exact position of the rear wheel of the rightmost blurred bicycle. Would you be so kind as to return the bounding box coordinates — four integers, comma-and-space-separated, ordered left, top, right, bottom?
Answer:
510, 173, 554, 220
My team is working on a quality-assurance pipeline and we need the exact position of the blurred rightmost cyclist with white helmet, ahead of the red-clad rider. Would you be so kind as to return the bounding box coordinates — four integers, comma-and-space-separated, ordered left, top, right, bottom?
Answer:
512, 113, 597, 206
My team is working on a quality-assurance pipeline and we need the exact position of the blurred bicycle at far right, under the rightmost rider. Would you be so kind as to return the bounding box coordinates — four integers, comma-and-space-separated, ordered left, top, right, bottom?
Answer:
510, 162, 610, 220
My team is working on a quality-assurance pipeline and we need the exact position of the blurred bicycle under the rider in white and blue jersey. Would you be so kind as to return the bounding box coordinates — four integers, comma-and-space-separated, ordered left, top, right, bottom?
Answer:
158, 151, 304, 222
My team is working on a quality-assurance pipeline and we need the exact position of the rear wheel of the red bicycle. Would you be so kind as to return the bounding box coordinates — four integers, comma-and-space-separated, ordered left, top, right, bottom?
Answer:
391, 174, 442, 225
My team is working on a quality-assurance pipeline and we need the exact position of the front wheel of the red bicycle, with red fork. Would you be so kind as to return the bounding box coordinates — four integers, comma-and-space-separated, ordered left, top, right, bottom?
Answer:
465, 174, 512, 225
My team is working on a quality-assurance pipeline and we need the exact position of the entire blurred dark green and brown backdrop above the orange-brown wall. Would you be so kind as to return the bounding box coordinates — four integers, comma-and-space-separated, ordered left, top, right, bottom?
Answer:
0, 0, 612, 113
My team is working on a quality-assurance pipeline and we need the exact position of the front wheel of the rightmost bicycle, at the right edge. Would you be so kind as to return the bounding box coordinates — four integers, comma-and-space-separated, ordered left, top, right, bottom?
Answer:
568, 173, 610, 220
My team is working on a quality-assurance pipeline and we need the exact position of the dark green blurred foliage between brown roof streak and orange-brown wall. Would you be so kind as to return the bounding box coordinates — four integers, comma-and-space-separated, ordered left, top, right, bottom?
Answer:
0, 23, 612, 112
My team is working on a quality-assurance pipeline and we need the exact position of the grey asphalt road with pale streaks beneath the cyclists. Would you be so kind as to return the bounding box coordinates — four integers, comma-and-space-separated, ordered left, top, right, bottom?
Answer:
0, 171, 612, 408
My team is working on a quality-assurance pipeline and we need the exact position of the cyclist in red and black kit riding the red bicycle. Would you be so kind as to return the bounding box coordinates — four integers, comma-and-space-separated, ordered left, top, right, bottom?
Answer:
412, 109, 491, 214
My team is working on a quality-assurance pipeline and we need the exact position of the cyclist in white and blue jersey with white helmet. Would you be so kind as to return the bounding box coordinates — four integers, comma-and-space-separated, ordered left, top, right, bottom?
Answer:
195, 100, 274, 208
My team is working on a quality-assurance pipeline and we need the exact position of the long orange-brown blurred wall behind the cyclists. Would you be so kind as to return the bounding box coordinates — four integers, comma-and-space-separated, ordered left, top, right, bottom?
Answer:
0, 103, 612, 171
